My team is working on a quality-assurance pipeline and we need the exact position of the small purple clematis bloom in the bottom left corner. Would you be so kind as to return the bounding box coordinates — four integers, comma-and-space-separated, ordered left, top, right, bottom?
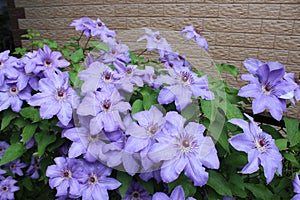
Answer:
0, 176, 20, 200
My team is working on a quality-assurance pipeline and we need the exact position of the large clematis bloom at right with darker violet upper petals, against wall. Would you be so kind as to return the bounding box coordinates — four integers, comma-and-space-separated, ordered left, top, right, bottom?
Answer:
238, 62, 297, 121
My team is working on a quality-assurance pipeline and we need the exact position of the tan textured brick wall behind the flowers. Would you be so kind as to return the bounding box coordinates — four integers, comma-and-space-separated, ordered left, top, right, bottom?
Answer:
14, 0, 300, 117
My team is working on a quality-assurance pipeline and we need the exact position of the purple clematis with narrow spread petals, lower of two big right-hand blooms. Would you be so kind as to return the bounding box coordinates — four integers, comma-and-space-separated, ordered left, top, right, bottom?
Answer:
229, 114, 282, 184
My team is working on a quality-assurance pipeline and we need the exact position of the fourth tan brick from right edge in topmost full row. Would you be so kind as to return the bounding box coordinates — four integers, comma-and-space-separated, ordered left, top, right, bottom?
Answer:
191, 4, 219, 17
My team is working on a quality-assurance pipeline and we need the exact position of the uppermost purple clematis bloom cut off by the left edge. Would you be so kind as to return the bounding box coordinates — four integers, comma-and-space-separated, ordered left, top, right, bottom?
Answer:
0, 50, 19, 86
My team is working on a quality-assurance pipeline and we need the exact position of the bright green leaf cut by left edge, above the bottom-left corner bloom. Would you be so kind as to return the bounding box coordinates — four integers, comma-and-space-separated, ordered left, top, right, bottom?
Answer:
0, 142, 26, 166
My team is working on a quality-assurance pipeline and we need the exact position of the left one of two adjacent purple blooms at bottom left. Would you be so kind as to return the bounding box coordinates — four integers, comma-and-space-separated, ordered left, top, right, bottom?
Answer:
46, 157, 83, 198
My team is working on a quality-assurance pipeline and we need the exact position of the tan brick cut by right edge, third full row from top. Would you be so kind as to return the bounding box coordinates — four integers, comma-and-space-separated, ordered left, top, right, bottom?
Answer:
275, 36, 300, 51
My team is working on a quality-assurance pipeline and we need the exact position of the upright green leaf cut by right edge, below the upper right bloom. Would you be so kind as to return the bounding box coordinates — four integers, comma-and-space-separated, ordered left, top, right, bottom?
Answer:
283, 117, 300, 147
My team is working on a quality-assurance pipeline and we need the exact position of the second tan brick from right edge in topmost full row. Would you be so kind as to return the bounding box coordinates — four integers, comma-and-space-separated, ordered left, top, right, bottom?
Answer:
248, 4, 280, 19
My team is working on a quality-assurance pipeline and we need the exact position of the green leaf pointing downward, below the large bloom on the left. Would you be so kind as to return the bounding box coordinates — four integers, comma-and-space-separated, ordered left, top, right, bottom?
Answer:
34, 132, 56, 157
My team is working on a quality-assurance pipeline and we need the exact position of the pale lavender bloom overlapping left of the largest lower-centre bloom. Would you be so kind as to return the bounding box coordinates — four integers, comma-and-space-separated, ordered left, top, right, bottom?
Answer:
126, 106, 165, 170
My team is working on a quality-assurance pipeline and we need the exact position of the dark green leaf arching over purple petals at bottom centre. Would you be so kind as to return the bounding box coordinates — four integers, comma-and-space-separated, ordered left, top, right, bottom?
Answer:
168, 173, 197, 197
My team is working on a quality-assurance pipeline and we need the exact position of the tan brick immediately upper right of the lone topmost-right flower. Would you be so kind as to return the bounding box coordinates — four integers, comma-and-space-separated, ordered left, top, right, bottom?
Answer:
203, 18, 231, 32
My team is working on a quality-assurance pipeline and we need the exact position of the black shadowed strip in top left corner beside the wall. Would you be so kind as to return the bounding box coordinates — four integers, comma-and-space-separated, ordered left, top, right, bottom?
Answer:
0, 0, 14, 52
